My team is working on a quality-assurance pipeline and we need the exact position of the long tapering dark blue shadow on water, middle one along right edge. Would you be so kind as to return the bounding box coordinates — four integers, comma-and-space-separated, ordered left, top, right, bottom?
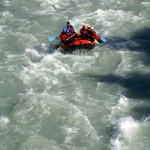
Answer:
84, 72, 150, 100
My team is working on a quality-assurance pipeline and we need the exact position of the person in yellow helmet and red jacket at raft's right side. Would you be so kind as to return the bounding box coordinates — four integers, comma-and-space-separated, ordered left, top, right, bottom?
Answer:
86, 25, 102, 43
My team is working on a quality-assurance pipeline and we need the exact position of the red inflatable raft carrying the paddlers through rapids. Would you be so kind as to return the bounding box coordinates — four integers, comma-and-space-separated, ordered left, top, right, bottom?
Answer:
60, 38, 95, 51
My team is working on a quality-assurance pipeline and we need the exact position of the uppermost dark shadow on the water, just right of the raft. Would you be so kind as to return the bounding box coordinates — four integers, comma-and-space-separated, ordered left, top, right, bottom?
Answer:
107, 28, 150, 54
